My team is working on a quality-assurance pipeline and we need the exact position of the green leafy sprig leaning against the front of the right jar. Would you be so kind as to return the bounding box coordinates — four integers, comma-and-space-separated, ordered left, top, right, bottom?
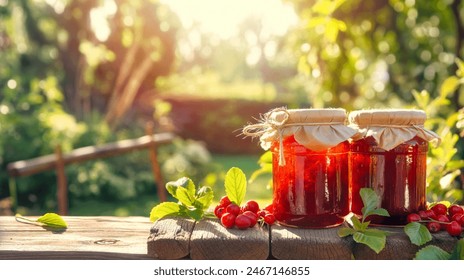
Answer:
338, 188, 390, 254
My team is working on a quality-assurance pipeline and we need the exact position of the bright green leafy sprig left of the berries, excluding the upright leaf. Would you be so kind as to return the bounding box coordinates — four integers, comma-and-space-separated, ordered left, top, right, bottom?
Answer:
150, 177, 214, 222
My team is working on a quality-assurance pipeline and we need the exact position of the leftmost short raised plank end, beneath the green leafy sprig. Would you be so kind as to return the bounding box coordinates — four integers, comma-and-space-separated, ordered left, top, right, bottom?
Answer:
147, 218, 195, 260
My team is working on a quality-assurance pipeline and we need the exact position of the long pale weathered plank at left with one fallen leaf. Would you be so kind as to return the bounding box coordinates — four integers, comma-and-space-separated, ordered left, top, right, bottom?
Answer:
0, 216, 152, 259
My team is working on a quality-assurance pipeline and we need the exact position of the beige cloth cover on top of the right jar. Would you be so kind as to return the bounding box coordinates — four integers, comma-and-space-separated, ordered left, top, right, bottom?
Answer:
348, 109, 441, 151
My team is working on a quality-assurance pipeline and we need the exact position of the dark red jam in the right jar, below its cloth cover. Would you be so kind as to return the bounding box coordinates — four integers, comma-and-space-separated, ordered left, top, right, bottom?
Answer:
349, 137, 428, 225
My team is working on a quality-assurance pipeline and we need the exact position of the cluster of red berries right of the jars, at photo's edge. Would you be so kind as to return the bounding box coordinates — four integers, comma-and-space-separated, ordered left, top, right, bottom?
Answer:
407, 203, 464, 236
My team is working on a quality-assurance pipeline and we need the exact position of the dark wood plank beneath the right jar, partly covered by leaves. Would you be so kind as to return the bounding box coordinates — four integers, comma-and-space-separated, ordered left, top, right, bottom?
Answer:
353, 227, 458, 260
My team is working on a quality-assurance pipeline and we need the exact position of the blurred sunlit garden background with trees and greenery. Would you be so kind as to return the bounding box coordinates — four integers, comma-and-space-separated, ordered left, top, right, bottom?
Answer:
0, 0, 464, 216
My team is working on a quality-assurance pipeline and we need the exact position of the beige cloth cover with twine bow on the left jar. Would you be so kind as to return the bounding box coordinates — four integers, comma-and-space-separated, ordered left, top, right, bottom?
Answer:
242, 107, 357, 166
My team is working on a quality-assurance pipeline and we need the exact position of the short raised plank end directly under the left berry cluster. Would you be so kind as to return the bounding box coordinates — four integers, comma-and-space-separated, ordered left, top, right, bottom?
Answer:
190, 219, 270, 260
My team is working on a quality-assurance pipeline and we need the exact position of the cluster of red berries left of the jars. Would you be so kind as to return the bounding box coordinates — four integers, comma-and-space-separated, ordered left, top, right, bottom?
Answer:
214, 196, 275, 229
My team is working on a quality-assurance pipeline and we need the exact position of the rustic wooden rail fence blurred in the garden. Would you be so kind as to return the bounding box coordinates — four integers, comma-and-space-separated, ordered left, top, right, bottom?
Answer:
7, 125, 175, 215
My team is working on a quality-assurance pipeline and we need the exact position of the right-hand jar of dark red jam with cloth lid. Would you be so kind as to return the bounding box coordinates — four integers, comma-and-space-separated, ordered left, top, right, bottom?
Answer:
349, 109, 439, 225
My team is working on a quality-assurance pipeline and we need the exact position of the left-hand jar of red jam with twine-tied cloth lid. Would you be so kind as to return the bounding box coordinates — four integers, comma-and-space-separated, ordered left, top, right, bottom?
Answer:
241, 109, 356, 228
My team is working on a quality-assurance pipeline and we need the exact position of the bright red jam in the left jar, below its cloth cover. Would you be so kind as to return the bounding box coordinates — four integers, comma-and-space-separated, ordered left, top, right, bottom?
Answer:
271, 136, 349, 228
